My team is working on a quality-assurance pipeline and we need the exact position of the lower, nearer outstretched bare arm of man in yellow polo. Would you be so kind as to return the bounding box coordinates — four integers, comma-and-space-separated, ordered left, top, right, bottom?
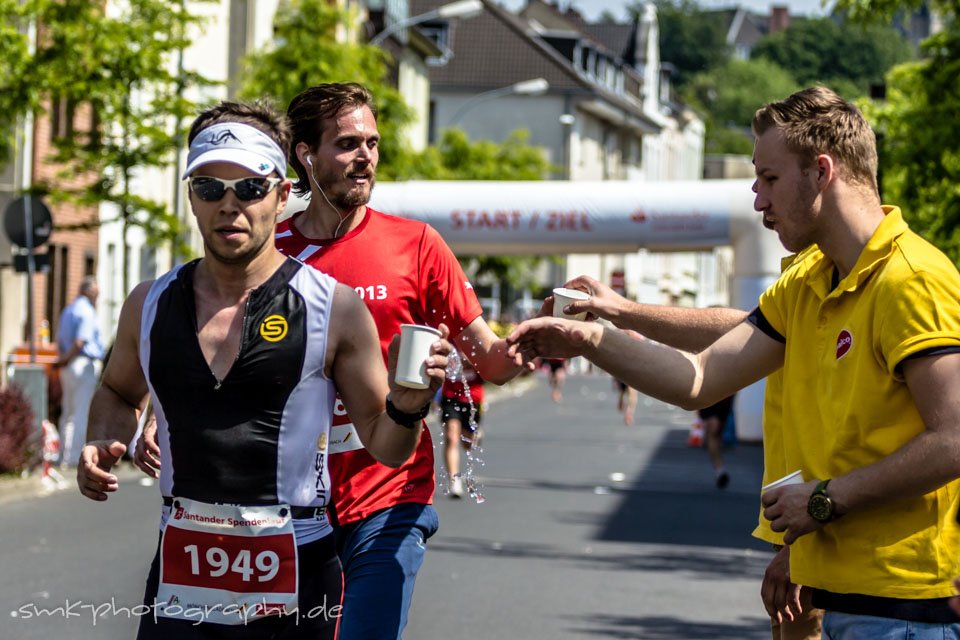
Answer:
507, 317, 784, 410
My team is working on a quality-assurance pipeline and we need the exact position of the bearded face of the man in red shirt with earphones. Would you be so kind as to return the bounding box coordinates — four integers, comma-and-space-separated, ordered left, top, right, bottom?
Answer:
307, 107, 380, 209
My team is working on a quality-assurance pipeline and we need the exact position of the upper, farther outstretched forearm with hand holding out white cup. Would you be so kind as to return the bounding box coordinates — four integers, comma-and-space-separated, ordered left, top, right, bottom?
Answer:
563, 276, 748, 353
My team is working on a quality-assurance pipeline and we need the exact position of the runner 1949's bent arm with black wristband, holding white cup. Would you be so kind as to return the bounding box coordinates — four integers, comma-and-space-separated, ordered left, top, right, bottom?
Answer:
326, 284, 450, 467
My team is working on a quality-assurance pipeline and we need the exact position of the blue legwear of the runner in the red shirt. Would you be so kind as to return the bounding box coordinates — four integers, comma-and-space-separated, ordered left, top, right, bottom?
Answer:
336, 503, 440, 640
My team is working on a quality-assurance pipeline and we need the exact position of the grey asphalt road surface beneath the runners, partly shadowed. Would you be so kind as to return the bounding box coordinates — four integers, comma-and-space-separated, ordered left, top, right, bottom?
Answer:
0, 374, 771, 640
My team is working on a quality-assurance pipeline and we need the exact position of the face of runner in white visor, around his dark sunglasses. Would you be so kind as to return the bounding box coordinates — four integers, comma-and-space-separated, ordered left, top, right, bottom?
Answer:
190, 162, 290, 264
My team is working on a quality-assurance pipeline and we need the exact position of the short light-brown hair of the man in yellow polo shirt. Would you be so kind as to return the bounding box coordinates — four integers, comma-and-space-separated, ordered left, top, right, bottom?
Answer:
752, 86, 878, 192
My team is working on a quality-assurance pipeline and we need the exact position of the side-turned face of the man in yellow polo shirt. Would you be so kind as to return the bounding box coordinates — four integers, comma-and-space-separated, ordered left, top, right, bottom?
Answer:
753, 128, 821, 252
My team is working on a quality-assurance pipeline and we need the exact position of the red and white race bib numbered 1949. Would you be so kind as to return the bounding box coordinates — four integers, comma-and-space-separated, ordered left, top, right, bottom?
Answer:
157, 498, 297, 624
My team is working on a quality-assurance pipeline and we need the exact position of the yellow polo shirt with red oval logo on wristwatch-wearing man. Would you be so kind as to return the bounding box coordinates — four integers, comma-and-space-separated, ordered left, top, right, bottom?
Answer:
760, 207, 960, 599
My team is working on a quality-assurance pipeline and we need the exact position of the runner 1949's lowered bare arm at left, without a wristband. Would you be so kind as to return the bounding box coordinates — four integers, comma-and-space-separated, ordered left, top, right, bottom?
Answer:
77, 282, 152, 501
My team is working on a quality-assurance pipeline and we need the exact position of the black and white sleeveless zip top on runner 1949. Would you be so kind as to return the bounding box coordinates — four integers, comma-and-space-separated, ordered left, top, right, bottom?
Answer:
140, 258, 336, 544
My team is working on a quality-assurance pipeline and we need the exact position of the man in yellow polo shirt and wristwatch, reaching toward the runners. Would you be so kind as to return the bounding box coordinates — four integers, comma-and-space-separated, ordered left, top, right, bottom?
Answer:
507, 87, 960, 640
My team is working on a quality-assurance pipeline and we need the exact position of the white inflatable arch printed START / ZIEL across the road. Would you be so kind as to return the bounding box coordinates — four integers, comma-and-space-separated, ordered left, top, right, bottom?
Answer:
294, 180, 785, 441
